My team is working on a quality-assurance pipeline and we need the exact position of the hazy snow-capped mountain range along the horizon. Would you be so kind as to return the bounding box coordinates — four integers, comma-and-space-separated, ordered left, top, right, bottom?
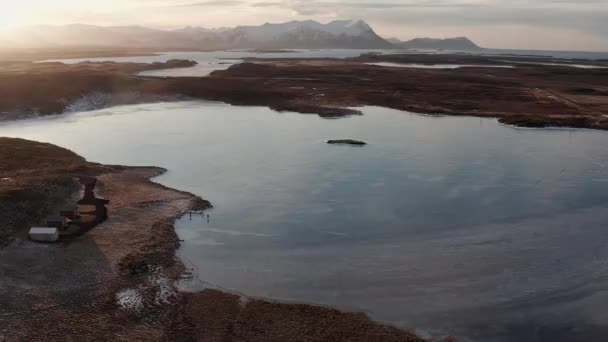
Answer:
0, 20, 479, 50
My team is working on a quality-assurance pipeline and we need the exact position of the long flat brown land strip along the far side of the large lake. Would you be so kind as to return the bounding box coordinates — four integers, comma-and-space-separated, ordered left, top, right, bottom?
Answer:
0, 55, 608, 129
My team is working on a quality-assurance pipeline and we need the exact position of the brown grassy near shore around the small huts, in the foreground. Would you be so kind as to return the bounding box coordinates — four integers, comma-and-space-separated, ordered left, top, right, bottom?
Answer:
0, 138, 423, 342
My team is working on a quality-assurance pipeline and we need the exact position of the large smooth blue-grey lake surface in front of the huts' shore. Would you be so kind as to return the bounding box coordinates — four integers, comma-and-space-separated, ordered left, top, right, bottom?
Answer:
0, 102, 608, 342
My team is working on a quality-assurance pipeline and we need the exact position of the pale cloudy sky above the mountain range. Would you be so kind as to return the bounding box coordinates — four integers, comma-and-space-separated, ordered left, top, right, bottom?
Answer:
0, 0, 608, 51
